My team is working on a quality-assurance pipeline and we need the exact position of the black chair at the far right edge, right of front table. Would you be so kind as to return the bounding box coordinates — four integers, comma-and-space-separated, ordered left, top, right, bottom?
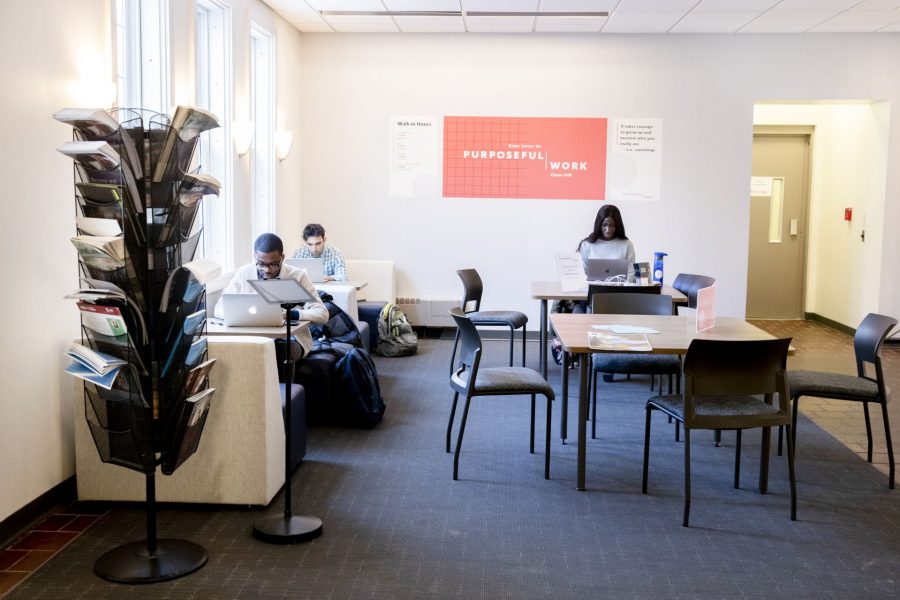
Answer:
778, 313, 897, 489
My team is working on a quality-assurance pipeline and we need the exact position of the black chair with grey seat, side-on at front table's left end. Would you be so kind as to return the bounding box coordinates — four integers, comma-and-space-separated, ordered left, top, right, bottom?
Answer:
447, 308, 553, 480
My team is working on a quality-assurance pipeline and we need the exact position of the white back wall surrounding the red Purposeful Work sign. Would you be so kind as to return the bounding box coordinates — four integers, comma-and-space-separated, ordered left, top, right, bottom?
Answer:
298, 34, 900, 319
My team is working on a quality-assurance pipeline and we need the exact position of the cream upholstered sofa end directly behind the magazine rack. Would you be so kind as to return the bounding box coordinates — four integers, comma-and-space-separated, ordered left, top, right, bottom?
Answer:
75, 336, 284, 505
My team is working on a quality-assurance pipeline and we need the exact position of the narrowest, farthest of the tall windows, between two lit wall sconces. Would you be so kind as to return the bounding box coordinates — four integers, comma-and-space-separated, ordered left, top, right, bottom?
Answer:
250, 23, 275, 244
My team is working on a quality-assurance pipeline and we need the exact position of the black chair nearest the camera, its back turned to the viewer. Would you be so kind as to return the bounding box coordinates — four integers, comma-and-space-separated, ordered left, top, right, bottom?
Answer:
641, 338, 797, 527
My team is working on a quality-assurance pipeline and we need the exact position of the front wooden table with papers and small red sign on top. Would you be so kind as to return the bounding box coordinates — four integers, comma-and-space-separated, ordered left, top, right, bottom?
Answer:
550, 314, 773, 490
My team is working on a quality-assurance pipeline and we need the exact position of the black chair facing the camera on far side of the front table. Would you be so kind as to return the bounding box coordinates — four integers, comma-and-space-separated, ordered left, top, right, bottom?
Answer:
590, 286, 681, 438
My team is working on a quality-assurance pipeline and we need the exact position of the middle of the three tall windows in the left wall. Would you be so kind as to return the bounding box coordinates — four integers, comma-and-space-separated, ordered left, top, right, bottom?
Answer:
196, 0, 234, 271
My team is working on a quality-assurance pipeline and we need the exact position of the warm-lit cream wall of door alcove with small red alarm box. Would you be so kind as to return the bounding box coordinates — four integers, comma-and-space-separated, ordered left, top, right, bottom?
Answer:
754, 102, 892, 327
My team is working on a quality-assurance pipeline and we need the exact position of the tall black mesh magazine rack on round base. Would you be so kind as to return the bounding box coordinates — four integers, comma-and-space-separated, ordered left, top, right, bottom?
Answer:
57, 107, 220, 583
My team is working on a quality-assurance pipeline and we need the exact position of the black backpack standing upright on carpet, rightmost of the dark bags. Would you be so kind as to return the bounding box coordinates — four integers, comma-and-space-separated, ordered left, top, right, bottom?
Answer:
334, 348, 385, 429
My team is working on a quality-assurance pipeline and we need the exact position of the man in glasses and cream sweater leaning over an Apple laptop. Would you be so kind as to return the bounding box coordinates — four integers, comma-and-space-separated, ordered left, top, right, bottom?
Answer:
214, 233, 328, 355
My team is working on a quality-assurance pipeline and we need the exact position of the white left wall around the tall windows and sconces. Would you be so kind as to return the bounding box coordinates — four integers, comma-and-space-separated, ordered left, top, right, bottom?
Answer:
0, 0, 300, 520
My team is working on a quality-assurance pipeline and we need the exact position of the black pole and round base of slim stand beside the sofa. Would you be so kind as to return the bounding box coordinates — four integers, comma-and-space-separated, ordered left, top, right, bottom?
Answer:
253, 303, 322, 544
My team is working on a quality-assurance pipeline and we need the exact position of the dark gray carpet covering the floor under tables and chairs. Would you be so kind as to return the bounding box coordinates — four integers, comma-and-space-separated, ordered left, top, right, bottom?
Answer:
8, 340, 900, 599
